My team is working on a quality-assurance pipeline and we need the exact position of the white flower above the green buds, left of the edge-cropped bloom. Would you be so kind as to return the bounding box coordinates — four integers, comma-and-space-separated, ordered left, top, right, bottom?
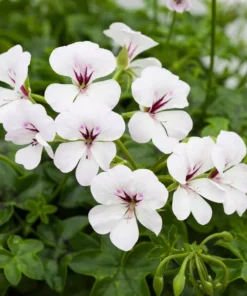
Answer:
167, 137, 224, 225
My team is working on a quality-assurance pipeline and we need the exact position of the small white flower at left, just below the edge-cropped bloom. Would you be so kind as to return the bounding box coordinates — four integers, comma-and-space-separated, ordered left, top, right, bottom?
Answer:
3, 100, 56, 170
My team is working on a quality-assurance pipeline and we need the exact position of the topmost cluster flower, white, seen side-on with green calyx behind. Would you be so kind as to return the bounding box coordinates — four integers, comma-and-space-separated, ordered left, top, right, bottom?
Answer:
104, 23, 162, 76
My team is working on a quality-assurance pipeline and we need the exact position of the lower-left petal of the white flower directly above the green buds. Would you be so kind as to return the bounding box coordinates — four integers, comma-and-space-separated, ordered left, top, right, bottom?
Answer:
172, 186, 191, 221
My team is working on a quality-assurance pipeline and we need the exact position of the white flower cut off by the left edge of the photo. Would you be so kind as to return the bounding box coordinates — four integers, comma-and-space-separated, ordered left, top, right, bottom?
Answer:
0, 45, 31, 123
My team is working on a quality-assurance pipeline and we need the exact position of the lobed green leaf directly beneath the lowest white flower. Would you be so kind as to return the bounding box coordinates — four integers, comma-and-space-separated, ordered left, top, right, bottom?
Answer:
69, 237, 158, 296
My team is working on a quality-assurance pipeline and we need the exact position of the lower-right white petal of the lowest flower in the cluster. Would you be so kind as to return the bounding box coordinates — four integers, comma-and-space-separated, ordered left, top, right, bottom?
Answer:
136, 205, 162, 235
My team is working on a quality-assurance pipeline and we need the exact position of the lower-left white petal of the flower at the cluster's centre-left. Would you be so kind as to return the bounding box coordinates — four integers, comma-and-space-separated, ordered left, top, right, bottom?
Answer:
54, 142, 86, 173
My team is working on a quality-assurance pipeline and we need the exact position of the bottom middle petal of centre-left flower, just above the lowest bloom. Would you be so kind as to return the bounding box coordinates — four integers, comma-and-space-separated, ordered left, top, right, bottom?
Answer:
76, 154, 99, 186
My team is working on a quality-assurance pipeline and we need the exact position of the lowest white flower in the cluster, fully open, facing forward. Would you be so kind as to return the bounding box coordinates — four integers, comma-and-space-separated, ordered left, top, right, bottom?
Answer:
88, 165, 168, 251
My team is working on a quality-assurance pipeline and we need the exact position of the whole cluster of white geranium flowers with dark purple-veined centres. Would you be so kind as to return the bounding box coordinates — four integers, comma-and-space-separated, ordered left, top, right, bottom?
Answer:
0, 22, 247, 251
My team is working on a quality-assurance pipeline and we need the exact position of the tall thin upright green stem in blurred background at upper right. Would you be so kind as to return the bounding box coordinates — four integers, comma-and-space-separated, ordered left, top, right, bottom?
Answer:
202, 0, 217, 114
